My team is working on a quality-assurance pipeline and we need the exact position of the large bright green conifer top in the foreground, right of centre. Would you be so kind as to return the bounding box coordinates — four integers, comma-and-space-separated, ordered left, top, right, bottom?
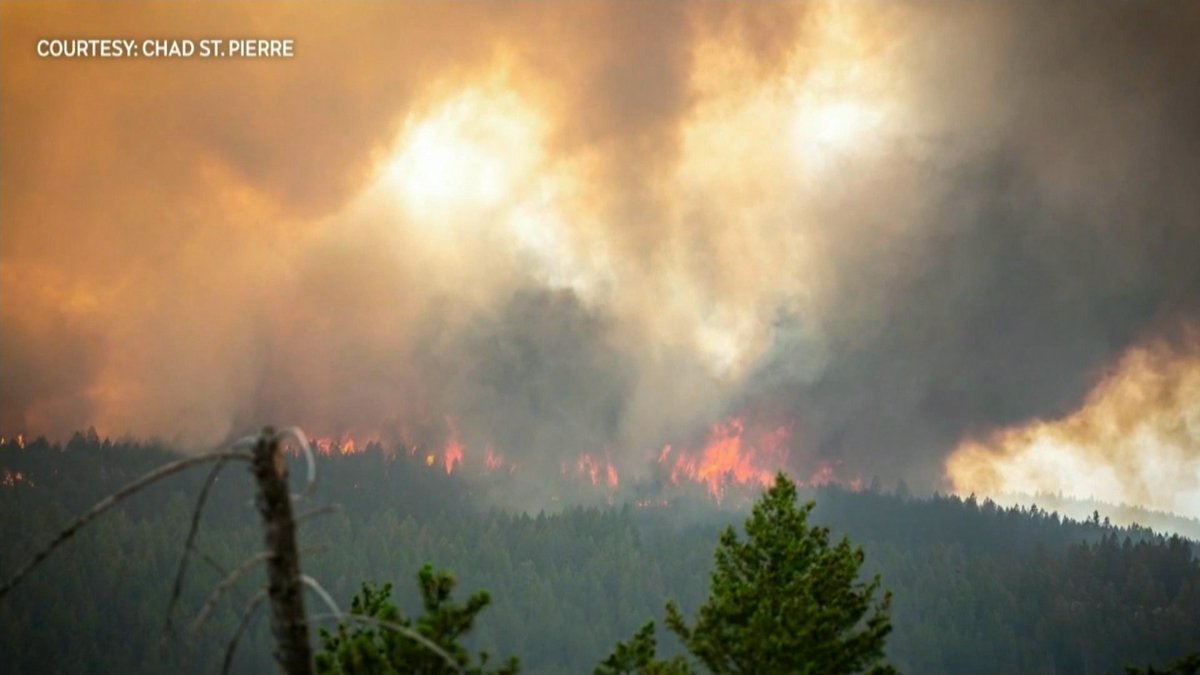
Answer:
667, 473, 892, 675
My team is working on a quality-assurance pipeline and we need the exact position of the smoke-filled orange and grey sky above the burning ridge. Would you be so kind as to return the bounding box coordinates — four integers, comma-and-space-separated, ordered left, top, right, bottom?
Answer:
0, 2, 1200, 515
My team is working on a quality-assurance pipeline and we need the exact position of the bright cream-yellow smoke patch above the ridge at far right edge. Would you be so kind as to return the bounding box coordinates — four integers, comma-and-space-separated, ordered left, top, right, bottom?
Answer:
946, 329, 1200, 516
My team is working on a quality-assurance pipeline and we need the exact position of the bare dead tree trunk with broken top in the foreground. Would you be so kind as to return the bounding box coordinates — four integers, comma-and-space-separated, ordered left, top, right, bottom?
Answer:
253, 426, 312, 675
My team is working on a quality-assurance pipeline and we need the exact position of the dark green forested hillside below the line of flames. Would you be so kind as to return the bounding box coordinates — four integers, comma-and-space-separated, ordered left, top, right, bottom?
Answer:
0, 436, 1200, 674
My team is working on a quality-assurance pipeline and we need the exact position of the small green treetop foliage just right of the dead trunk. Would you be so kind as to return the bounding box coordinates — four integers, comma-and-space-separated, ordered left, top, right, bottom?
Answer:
317, 565, 520, 675
